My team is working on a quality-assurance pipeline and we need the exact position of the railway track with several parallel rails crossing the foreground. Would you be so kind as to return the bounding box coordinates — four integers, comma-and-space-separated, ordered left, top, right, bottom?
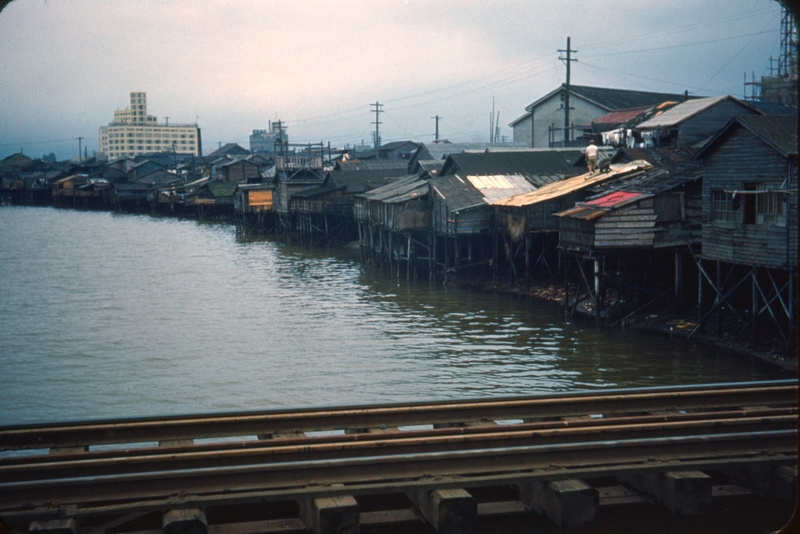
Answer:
0, 381, 798, 534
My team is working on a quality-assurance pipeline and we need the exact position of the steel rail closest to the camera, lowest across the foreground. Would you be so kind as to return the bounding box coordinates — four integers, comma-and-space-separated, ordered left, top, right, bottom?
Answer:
0, 430, 797, 513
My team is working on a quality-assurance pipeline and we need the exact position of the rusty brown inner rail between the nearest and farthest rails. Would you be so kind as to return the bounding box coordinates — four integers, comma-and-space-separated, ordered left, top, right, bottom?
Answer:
0, 413, 797, 482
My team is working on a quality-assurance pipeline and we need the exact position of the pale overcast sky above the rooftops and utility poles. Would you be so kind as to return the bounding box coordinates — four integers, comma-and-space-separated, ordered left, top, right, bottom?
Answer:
0, 0, 792, 159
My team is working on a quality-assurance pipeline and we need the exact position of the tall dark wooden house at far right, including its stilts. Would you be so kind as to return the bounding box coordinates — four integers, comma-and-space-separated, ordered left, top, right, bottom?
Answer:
697, 115, 798, 350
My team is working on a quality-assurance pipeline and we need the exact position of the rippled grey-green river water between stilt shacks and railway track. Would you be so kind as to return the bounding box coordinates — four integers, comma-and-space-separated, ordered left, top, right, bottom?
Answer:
0, 207, 790, 425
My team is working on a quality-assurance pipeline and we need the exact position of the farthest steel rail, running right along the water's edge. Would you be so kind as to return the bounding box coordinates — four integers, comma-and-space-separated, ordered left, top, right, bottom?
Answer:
0, 380, 797, 450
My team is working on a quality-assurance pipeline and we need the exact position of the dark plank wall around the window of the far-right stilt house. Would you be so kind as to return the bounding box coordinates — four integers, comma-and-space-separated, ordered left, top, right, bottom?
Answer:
702, 127, 797, 268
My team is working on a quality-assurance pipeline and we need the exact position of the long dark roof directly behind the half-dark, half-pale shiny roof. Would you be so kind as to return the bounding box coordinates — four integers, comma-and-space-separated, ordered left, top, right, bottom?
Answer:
439, 148, 583, 185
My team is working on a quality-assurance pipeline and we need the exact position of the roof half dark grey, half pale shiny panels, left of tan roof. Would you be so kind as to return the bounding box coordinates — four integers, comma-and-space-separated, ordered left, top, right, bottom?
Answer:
430, 174, 536, 212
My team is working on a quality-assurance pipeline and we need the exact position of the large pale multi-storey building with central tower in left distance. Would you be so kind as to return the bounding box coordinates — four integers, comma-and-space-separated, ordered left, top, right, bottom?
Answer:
99, 92, 203, 159
